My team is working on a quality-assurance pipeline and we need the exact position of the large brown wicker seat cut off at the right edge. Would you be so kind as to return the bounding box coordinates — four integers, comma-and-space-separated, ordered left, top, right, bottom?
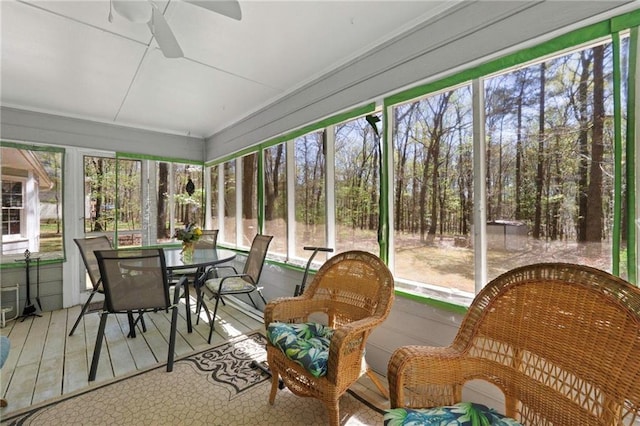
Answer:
387, 263, 640, 426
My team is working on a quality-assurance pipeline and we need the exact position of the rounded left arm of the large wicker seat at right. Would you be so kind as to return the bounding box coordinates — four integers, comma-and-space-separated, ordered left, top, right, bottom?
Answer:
387, 346, 468, 408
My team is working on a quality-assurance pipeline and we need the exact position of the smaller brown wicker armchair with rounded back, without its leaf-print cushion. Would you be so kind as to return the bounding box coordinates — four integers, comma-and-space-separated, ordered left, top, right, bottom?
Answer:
264, 251, 394, 425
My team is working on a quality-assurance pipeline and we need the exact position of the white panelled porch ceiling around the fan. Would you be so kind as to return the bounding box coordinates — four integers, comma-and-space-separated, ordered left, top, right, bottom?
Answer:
0, 0, 458, 138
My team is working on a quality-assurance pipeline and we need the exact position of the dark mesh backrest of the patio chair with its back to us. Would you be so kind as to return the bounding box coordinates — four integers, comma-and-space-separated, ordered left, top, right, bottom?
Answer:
96, 249, 171, 312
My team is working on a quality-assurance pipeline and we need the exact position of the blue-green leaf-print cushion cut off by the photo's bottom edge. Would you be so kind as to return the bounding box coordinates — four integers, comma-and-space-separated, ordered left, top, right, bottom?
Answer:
384, 402, 521, 426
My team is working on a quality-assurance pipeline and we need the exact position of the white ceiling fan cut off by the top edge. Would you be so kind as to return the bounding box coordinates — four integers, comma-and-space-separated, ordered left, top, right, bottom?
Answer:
109, 0, 242, 58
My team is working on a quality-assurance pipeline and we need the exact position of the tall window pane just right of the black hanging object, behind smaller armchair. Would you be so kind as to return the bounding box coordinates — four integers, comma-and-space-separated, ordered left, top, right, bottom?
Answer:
393, 85, 474, 292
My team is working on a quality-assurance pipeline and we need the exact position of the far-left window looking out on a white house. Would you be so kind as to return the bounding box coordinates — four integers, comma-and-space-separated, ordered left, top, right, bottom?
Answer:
0, 142, 64, 259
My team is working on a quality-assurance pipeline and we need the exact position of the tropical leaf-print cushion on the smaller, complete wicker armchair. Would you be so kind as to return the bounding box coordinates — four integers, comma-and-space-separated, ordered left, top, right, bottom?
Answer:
267, 322, 333, 377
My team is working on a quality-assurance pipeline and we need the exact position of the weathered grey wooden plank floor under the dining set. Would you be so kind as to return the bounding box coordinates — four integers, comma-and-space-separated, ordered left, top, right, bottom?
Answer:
0, 292, 264, 419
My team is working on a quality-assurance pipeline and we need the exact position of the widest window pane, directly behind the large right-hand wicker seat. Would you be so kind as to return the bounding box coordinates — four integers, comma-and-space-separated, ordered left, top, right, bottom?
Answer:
485, 38, 615, 279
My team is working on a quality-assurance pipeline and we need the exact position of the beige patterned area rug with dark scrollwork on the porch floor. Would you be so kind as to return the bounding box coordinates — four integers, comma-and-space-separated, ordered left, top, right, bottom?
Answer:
2, 332, 382, 425
